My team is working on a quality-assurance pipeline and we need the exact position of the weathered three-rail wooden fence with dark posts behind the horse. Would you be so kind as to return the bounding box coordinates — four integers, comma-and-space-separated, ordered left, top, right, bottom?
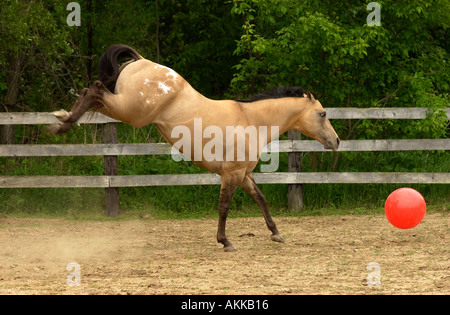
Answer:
0, 108, 450, 216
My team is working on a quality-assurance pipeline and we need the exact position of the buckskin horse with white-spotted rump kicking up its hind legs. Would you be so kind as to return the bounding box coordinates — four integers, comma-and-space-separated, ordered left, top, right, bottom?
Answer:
47, 45, 340, 252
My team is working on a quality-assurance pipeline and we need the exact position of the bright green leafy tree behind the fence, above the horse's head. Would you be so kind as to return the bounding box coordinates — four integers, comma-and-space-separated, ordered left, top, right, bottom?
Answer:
232, 0, 450, 138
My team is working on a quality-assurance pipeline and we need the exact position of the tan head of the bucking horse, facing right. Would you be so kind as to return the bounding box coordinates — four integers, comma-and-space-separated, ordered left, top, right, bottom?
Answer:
298, 92, 340, 151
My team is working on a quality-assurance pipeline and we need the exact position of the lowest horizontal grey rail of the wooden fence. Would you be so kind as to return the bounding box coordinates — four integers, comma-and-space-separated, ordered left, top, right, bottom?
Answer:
0, 172, 450, 188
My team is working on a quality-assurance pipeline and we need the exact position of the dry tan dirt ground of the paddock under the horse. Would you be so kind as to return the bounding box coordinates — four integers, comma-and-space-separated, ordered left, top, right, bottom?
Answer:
0, 214, 450, 295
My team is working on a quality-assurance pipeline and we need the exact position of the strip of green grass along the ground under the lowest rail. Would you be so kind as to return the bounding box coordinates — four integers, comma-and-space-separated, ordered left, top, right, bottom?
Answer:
0, 185, 450, 221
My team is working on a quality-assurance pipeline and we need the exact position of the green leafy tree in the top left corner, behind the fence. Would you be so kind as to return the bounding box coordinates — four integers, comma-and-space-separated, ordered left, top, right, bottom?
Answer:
0, 0, 70, 143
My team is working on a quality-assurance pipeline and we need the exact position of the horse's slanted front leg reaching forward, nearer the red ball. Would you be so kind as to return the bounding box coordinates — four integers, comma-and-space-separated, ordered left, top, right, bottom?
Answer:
241, 174, 284, 243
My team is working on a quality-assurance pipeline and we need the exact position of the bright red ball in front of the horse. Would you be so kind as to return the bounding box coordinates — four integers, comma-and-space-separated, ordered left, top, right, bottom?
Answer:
384, 188, 427, 229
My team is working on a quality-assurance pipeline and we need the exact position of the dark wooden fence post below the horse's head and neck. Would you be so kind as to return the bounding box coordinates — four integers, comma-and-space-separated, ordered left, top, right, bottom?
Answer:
288, 130, 303, 212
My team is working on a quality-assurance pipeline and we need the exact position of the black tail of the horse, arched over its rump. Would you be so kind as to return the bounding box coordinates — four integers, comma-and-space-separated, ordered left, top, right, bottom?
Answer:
98, 45, 142, 93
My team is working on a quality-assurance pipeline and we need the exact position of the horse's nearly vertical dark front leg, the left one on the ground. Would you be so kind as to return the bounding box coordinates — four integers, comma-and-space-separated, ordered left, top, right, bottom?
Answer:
217, 174, 243, 252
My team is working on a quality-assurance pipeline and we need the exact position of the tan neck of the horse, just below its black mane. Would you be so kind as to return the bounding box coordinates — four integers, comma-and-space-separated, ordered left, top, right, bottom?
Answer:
241, 97, 307, 142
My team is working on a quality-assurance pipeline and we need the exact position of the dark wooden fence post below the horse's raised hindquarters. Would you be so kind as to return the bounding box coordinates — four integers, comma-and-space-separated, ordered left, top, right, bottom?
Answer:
103, 123, 120, 217
